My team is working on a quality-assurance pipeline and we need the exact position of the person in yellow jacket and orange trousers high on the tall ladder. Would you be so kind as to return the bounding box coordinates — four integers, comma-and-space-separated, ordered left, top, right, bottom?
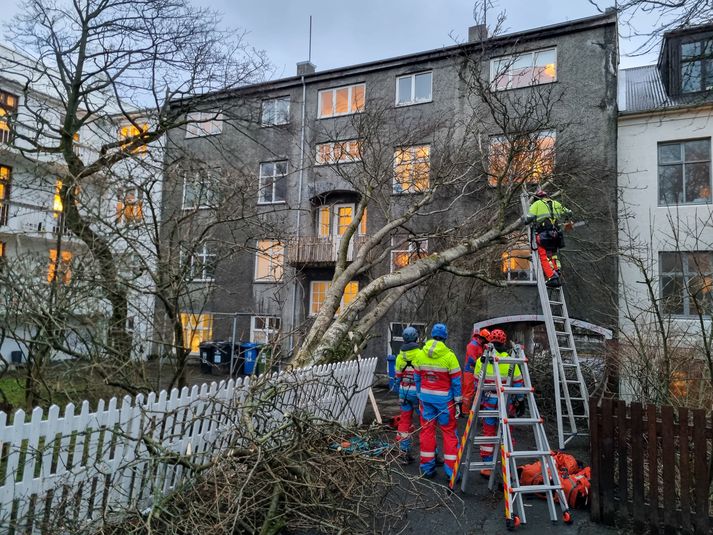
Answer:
527, 188, 572, 288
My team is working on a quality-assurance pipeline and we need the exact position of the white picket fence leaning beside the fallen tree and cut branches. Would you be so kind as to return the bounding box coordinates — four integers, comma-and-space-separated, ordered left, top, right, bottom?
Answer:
0, 359, 376, 533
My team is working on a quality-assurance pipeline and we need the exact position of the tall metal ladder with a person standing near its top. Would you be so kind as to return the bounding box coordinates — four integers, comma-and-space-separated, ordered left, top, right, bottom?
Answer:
520, 193, 589, 449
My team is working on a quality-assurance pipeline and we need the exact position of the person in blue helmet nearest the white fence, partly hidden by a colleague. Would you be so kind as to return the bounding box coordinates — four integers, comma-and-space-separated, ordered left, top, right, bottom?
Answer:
396, 326, 423, 464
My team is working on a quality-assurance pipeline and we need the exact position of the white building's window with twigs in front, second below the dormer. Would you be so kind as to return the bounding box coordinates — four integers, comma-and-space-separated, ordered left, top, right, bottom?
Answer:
659, 251, 713, 316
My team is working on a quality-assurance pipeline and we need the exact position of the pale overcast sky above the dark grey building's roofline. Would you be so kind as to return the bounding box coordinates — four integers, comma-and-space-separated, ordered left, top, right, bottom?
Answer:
5, 0, 656, 78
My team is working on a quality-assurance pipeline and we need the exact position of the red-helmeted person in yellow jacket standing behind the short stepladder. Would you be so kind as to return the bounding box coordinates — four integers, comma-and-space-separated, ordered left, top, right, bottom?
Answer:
474, 329, 524, 477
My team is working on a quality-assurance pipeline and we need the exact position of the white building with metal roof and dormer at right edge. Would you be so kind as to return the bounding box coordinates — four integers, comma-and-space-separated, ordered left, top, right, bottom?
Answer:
618, 24, 713, 398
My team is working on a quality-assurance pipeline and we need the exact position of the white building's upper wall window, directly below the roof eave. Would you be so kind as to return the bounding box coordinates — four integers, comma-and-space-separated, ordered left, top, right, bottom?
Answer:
658, 138, 711, 206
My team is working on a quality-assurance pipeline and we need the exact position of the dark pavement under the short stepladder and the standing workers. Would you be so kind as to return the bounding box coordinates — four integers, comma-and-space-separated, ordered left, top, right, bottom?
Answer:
365, 389, 620, 535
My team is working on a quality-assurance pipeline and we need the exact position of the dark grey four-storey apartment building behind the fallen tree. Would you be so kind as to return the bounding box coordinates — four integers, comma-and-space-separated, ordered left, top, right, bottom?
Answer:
163, 13, 618, 366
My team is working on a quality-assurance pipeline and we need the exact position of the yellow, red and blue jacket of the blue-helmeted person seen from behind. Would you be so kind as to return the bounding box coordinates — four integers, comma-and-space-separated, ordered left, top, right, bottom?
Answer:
414, 340, 462, 405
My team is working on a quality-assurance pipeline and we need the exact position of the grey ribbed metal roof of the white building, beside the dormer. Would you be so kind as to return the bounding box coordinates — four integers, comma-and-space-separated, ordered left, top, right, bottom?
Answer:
619, 65, 713, 115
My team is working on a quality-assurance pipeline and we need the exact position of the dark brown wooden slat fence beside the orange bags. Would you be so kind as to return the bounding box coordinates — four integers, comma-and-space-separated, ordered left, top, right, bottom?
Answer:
589, 399, 713, 534
